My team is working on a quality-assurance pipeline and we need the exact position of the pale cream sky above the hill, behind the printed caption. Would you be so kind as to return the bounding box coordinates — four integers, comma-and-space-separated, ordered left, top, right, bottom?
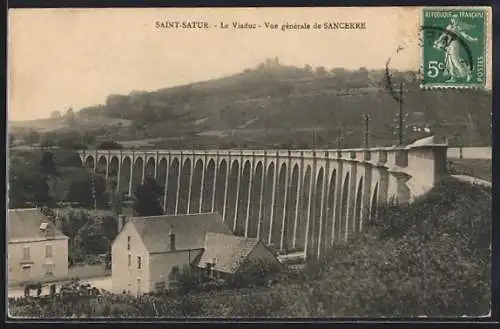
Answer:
8, 7, 466, 121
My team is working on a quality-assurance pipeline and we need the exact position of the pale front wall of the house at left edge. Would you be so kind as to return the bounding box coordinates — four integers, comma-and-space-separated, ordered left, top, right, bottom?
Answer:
7, 239, 68, 285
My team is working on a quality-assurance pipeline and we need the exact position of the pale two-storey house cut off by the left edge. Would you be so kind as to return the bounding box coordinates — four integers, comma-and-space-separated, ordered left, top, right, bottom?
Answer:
7, 208, 69, 285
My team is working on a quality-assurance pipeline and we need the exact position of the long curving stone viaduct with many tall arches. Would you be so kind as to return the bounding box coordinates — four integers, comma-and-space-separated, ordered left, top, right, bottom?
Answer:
79, 138, 447, 258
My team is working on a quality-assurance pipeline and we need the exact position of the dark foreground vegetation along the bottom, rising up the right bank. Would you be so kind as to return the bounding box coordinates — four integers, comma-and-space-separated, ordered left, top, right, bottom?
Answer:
9, 180, 491, 318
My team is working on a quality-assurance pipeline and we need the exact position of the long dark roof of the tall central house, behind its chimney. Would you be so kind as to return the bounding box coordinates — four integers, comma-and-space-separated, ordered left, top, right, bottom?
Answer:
130, 213, 233, 253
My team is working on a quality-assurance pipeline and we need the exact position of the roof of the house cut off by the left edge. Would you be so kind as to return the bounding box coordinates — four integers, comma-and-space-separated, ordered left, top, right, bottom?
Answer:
7, 208, 67, 241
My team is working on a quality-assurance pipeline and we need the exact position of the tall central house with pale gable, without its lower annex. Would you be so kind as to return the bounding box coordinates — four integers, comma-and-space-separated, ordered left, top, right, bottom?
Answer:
111, 213, 233, 295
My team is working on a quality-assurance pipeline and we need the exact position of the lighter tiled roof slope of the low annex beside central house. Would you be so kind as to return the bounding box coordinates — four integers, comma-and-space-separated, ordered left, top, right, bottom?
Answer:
198, 232, 259, 274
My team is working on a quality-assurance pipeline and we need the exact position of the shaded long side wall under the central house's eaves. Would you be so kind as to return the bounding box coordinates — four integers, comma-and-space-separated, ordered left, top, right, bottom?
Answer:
148, 249, 203, 291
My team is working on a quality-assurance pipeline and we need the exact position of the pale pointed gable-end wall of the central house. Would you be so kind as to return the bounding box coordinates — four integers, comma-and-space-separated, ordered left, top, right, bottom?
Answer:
111, 222, 149, 295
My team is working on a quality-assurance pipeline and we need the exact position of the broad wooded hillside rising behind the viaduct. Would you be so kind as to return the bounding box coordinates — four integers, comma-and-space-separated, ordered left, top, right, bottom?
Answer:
8, 63, 492, 147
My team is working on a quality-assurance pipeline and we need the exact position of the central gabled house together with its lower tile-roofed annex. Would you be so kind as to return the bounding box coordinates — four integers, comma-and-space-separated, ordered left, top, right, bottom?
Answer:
111, 213, 278, 295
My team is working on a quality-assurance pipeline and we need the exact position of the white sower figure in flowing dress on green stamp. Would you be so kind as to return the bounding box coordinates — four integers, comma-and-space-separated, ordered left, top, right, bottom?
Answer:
434, 15, 477, 82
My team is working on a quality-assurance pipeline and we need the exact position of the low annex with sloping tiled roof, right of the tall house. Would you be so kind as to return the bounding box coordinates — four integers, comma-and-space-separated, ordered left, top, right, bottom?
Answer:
197, 232, 281, 279
